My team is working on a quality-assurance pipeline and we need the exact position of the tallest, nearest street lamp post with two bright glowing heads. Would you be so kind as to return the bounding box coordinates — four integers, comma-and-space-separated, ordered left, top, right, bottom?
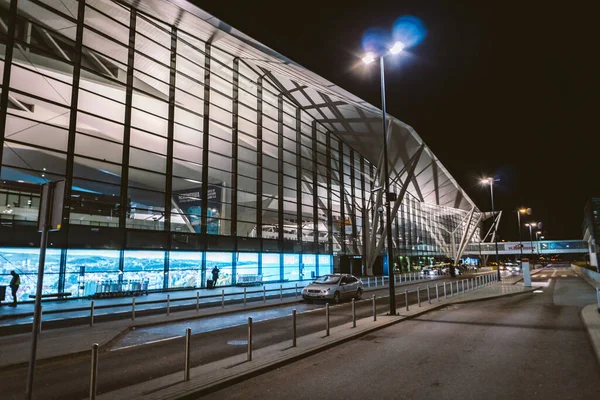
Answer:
363, 42, 404, 315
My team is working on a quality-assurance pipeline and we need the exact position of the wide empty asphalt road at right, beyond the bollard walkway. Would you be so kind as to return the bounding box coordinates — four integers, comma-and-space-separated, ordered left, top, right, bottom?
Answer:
206, 267, 600, 400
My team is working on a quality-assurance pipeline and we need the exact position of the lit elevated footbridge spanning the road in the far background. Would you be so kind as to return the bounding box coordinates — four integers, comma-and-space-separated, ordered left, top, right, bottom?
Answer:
464, 240, 588, 256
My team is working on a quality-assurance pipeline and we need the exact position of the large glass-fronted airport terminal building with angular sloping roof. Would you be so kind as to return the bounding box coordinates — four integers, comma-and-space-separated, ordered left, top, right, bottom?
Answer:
0, 0, 489, 297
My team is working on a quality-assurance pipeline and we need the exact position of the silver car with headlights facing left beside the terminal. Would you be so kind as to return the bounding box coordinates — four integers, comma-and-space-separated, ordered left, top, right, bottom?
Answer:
302, 274, 363, 303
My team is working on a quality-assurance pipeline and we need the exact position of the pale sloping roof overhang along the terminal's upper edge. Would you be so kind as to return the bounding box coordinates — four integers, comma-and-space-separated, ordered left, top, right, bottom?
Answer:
50, 0, 478, 210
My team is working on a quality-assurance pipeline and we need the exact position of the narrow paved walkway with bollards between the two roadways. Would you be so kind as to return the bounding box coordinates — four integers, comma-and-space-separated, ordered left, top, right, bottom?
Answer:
98, 283, 534, 399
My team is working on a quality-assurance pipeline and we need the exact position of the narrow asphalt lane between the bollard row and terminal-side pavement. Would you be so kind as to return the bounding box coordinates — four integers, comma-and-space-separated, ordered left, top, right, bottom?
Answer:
0, 279, 464, 399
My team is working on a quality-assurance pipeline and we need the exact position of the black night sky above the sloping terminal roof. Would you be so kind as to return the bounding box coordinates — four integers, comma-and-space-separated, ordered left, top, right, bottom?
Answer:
195, 0, 600, 240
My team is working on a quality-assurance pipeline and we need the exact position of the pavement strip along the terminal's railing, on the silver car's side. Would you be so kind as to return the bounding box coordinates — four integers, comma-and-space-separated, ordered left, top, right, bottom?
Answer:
0, 277, 446, 370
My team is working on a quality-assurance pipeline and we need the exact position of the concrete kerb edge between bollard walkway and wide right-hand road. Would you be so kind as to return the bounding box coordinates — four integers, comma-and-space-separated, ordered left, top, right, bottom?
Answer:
99, 282, 536, 399
